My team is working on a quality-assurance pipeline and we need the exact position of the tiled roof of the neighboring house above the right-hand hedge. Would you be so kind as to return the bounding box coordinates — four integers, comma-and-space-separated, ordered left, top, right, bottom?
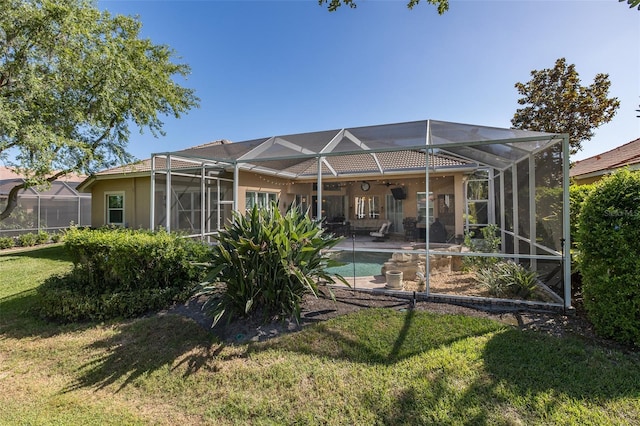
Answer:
569, 138, 640, 185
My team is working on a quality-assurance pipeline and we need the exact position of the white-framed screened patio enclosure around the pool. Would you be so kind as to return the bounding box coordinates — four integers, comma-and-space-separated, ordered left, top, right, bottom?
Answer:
150, 120, 571, 308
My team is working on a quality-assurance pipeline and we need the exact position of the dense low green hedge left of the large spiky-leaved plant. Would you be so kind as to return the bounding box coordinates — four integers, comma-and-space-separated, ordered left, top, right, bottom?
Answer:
38, 228, 209, 321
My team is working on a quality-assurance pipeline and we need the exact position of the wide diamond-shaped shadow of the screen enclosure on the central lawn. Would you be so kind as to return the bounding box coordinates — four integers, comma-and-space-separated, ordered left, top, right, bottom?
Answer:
247, 308, 504, 365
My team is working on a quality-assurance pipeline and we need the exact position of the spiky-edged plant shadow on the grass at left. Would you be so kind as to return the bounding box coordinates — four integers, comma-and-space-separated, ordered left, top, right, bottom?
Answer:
64, 315, 224, 392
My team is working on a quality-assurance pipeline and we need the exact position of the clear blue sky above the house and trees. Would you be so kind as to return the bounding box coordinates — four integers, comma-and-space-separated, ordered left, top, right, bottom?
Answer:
98, 0, 640, 160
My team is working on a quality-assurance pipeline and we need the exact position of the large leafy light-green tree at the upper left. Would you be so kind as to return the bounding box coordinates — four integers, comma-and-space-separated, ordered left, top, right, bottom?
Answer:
0, 0, 198, 220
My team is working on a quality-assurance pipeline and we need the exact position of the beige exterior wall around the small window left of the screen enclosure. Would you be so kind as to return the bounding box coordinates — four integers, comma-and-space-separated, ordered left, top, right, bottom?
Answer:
91, 176, 151, 228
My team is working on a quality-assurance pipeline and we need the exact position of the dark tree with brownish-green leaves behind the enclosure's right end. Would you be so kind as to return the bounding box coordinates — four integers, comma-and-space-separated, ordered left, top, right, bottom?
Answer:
511, 58, 620, 154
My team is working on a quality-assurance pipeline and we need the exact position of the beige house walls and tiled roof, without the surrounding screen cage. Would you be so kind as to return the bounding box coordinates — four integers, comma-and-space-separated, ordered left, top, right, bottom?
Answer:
79, 140, 472, 240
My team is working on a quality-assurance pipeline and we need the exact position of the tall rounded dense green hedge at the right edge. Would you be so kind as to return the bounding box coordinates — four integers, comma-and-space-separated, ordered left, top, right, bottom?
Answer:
578, 170, 640, 345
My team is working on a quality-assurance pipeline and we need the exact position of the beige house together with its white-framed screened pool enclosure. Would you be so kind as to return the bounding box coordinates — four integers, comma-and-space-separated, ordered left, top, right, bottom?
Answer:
78, 120, 571, 307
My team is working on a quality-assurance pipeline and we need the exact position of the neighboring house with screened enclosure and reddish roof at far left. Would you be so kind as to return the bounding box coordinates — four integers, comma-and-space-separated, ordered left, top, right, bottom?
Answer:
0, 167, 91, 236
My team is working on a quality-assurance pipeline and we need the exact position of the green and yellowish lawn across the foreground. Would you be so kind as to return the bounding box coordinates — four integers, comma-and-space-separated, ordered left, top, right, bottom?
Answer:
0, 247, 640, 425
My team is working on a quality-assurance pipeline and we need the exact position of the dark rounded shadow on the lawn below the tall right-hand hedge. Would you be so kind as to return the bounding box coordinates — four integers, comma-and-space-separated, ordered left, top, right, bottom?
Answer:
484, 330, 640, 401
